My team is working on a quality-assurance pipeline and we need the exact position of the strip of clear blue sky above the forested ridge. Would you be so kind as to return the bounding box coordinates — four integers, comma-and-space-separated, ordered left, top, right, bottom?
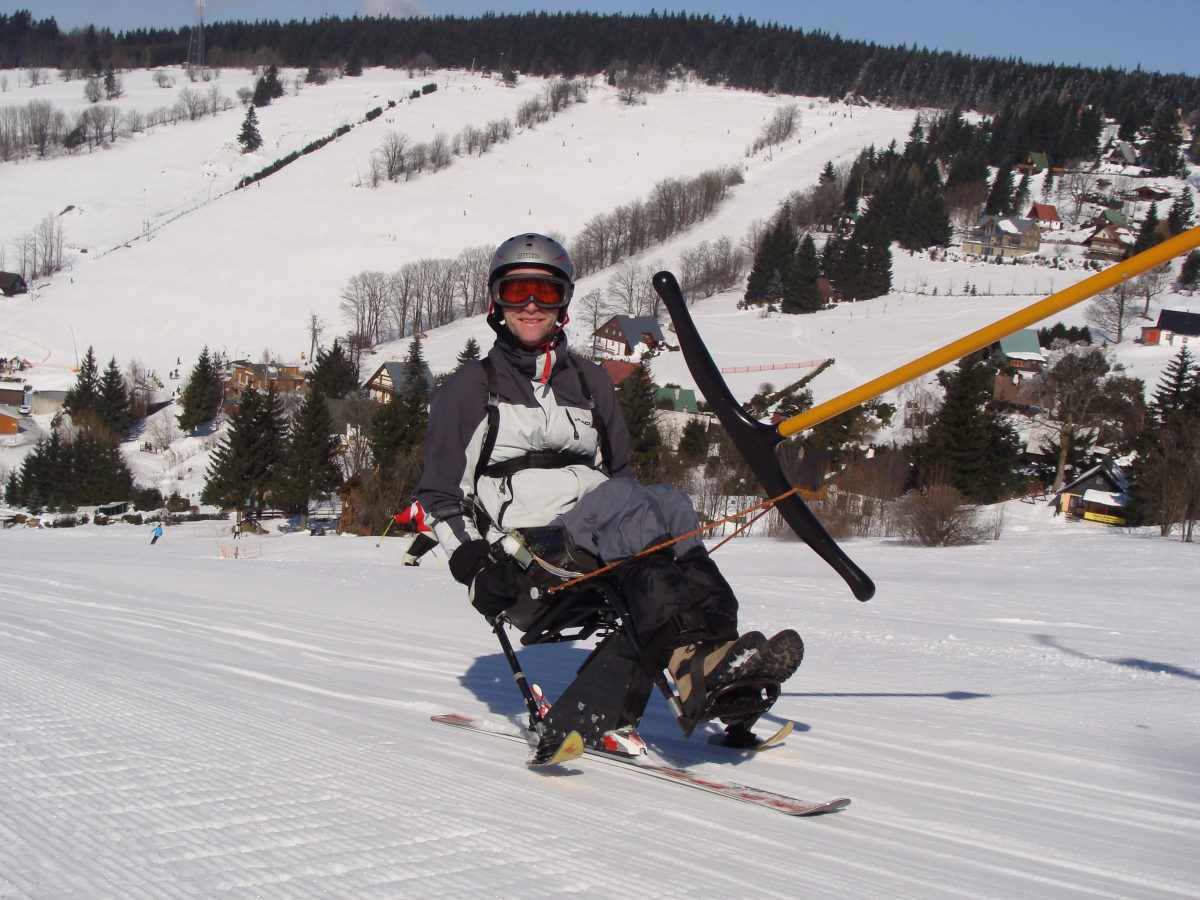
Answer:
7, 0, 1200, 76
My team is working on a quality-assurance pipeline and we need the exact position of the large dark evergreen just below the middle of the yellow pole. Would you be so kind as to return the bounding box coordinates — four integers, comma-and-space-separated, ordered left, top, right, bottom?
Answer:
914, 355, 1020, 503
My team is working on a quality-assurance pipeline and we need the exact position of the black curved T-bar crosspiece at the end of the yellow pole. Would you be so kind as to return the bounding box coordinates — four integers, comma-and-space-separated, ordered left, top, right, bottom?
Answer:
654, 271, 875, 601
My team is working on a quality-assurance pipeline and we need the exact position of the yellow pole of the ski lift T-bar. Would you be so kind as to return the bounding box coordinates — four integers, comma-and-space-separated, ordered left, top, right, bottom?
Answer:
776, 226, 1200, 438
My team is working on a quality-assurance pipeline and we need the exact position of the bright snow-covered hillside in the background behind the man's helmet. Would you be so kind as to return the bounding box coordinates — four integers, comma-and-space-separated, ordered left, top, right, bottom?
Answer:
0, 70, 1200, 466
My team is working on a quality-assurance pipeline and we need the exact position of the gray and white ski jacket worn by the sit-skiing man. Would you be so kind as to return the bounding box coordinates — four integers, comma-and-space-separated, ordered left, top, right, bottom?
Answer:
416, 334, 630, 554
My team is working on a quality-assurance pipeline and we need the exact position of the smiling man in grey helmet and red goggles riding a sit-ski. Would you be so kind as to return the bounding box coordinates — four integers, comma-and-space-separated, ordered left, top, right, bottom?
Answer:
415, 234, 803, 746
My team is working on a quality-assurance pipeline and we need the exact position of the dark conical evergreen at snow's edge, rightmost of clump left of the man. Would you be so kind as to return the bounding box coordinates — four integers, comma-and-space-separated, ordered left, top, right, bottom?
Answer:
271, 391, 342, 528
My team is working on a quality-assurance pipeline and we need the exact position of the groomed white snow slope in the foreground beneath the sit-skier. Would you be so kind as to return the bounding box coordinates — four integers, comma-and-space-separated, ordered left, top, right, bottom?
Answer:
0, 502, 1200, 899
